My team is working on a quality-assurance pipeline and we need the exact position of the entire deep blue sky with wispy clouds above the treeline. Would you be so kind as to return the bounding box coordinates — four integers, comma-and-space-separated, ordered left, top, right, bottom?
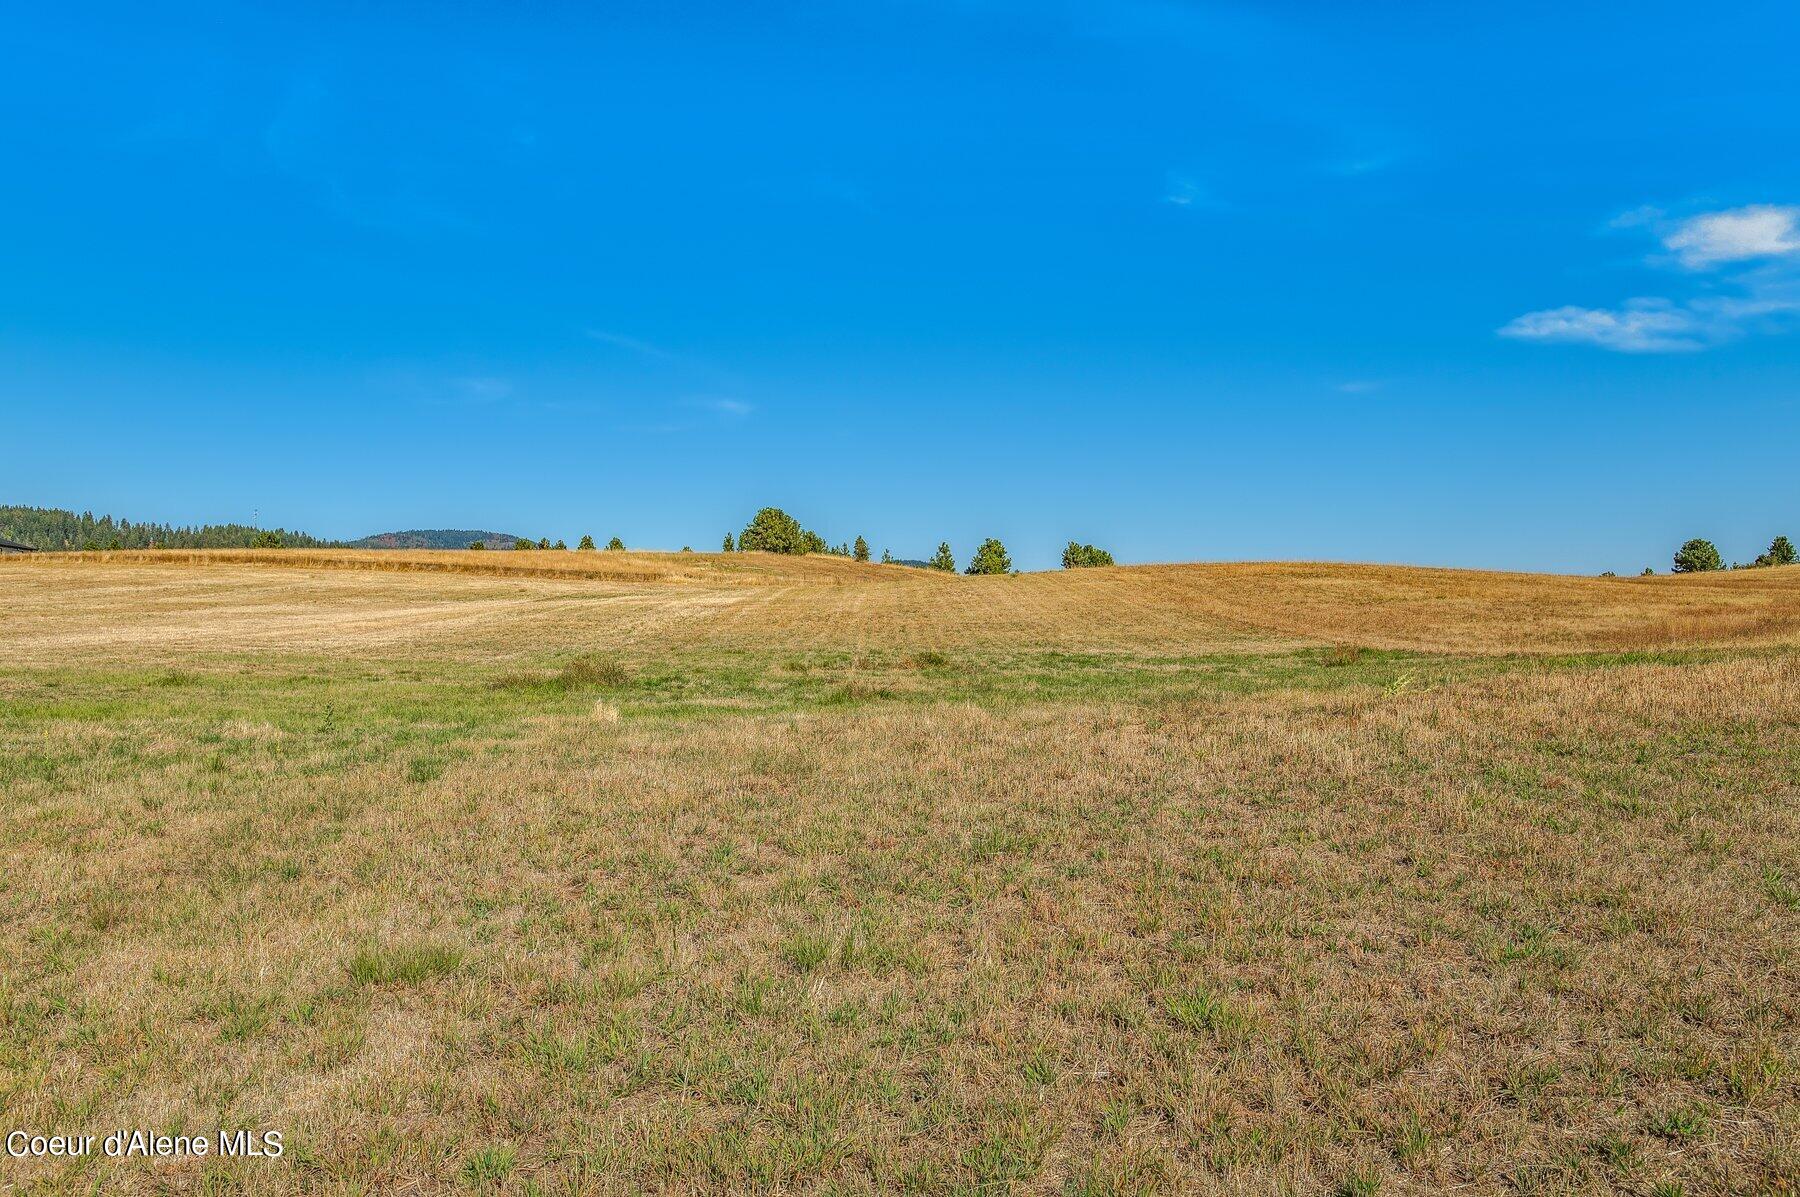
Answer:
0, 0, 1800, 572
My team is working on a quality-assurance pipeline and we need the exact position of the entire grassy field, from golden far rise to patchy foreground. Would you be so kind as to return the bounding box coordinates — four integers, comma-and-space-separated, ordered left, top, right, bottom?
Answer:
0, 551, 1800, 1195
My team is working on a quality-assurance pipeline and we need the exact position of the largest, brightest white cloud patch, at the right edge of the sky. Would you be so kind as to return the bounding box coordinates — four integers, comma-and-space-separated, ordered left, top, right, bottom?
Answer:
1498, 203, 1800, 353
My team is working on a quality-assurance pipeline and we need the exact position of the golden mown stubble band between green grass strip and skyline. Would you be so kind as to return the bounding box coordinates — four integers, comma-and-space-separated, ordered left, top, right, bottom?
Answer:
0, 551, 1800, 657
